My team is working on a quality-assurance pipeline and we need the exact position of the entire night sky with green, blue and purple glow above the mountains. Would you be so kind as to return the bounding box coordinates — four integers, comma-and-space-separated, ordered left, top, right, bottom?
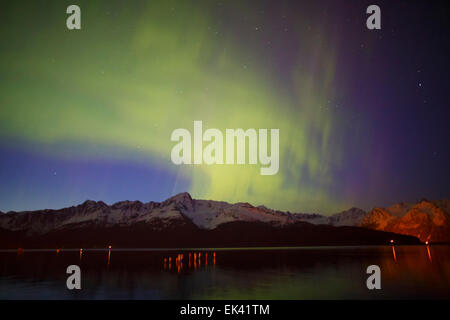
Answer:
0, 0, 450, 214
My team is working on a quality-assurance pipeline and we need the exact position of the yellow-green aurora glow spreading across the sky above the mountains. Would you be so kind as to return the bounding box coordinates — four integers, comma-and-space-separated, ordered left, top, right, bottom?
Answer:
0, 1, 370, 212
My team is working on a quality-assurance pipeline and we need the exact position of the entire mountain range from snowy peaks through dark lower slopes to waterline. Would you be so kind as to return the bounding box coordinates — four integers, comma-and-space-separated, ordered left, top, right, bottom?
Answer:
0, 192, 450, 248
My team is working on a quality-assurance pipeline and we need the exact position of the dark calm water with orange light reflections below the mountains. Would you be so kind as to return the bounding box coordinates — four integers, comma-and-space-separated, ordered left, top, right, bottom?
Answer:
0, 246, 450, 299
